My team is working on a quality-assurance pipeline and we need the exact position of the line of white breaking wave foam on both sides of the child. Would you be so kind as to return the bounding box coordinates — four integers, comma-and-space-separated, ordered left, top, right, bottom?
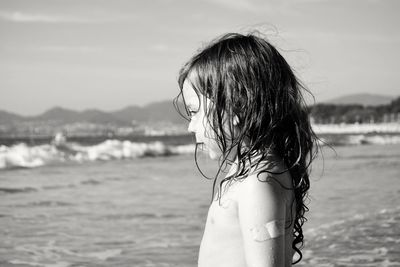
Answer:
0, 131, 400, 169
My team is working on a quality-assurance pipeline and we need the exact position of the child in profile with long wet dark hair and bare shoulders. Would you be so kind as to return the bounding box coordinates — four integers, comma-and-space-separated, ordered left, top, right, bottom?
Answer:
174, 33, 316, 267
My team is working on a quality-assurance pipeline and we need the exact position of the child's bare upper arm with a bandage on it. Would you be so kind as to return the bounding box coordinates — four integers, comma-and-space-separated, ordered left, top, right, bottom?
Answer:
238, 174, 286, 267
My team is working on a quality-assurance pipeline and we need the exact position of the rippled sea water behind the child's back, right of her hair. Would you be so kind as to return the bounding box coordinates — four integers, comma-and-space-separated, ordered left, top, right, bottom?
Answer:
301, 145, 400, 266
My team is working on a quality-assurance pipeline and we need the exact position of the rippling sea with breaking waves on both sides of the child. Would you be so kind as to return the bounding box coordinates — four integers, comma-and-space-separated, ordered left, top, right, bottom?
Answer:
0, 136, 400, 267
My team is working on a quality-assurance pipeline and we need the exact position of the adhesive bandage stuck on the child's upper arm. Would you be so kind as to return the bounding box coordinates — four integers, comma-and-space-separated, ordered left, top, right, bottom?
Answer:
250, 220, 285, 242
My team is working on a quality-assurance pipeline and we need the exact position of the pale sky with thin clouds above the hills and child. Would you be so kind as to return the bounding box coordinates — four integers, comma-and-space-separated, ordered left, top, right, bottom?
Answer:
0, 0, 400, 115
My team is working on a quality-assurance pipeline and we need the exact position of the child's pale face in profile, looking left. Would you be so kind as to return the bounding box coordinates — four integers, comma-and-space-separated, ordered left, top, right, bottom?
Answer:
182, 79, 221, 159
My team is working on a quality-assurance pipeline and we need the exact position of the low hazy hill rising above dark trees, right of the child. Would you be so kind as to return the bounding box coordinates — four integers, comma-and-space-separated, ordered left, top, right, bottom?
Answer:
323, 94, 395, 106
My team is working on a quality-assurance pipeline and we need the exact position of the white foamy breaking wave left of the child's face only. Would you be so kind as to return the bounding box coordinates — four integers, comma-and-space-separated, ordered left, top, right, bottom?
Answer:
0, 140, 194, 169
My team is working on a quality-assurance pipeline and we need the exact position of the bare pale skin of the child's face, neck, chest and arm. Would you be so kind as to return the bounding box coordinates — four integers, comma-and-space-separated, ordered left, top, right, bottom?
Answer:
182, 78, 295, 267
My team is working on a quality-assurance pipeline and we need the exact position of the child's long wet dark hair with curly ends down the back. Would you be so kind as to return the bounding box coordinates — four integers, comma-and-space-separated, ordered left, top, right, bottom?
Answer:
174, 33, 318, 264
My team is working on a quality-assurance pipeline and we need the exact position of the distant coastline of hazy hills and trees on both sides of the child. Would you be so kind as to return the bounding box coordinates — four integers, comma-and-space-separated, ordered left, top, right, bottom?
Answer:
0, 94, 400, 142
